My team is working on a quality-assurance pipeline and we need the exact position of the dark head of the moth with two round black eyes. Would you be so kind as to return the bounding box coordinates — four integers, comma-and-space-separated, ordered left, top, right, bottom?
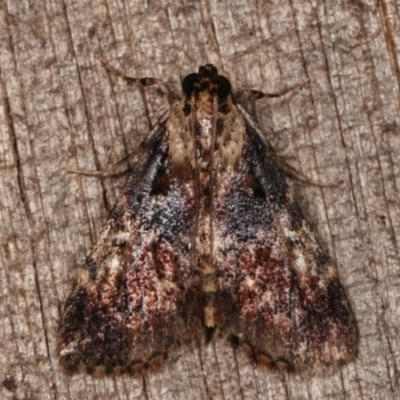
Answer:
182, 64, 231, 99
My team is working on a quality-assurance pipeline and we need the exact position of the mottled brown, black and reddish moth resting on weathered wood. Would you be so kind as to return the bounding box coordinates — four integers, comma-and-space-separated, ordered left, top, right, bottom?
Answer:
58, 64, 357, 367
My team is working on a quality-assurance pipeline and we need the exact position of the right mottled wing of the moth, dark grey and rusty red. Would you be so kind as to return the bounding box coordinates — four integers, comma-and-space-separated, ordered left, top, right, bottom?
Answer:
215, 115, 357, 364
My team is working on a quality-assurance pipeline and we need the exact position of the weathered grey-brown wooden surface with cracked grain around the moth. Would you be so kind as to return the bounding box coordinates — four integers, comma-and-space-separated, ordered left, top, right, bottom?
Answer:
0, 0, 400, 399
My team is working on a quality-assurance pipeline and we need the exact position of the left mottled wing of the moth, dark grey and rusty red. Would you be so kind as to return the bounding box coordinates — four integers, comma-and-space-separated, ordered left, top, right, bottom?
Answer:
58, 110, 200, 367
